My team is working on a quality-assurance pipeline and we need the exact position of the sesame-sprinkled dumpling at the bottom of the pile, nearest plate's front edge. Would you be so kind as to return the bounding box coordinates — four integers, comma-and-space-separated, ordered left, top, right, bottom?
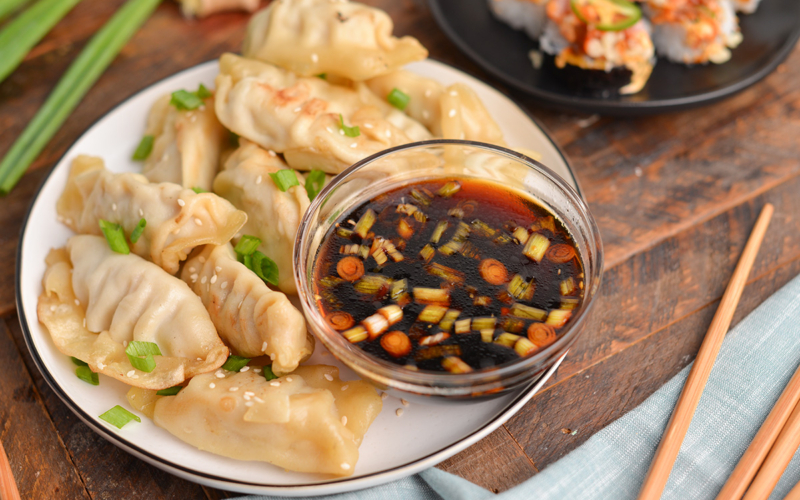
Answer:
143, 366, 382, 476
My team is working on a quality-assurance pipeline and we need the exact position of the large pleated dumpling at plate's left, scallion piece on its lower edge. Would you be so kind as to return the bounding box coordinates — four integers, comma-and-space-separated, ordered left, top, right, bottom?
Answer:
37, 235, 228, 390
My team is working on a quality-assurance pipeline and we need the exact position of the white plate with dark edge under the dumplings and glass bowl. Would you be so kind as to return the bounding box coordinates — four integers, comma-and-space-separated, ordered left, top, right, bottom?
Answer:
17, 61, 577, 496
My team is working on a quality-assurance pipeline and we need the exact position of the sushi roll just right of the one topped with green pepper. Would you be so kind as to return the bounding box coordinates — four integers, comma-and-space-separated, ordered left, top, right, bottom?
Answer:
644, 0, 742, 64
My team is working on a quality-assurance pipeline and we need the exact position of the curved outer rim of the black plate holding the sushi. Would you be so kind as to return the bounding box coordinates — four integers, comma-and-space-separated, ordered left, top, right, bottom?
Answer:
427, 0, 800, 114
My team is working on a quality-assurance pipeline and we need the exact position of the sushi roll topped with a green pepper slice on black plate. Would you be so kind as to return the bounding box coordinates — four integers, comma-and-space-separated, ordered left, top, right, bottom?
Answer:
539, 0, 655, 94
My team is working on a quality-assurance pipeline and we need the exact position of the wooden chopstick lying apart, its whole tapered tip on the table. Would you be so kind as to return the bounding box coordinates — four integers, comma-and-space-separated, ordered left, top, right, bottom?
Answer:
639, 203, 774, 500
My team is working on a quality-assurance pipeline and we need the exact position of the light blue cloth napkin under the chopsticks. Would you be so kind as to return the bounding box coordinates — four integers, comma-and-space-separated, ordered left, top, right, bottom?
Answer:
236, 276, 800, 500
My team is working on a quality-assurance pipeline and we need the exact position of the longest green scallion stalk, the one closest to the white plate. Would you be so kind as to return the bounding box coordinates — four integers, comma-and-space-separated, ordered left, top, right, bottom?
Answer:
0, 0, 161, 194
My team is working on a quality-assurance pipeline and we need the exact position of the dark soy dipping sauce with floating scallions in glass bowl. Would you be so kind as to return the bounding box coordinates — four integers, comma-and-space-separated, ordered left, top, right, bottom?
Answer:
315, 178, 583, 372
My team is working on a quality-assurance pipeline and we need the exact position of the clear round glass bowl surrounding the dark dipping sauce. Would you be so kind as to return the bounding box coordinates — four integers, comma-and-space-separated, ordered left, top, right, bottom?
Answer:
294, 139, 603, 400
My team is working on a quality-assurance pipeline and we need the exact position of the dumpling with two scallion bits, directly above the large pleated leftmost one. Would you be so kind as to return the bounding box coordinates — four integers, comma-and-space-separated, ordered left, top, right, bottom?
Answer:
56, 156, 247, 274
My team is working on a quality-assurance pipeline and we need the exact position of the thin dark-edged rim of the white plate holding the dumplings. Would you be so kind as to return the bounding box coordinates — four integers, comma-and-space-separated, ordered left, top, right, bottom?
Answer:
14, 58, 585, 496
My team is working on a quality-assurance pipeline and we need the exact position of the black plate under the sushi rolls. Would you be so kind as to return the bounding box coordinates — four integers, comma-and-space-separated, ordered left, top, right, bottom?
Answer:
428, 0, 800, 115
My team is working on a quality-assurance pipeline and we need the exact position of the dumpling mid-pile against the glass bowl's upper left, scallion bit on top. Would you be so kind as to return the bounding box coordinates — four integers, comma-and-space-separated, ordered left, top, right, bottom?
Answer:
214, 139, 309, 294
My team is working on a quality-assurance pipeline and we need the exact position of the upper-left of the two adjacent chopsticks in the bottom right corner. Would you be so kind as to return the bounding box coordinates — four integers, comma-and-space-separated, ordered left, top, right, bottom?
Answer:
717, 360, 800, 500
